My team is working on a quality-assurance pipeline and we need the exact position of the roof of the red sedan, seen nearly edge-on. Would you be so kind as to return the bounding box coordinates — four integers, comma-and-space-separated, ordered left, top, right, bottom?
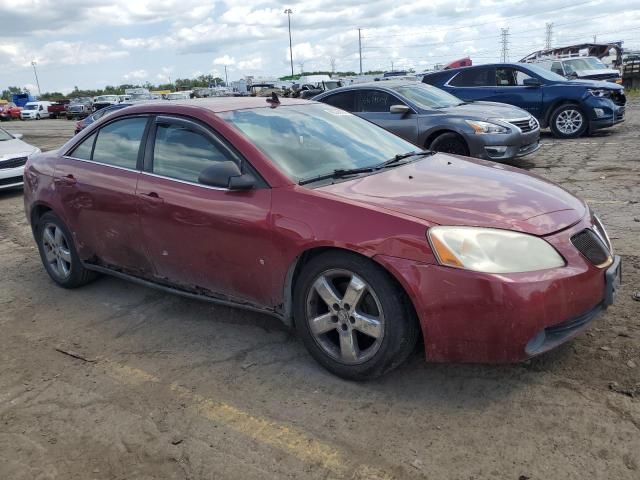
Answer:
118, 97, 316, 113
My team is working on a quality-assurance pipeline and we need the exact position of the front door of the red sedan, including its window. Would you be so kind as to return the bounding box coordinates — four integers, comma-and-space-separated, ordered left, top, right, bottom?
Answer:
137, 116, 274, 305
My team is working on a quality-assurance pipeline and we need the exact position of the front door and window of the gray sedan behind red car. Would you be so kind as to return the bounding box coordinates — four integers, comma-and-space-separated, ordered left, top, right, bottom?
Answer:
353, 89, 418, 144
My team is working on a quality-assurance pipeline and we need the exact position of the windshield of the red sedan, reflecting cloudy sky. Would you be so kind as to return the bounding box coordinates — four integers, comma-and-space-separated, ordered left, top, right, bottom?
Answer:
220, 104, 416, 182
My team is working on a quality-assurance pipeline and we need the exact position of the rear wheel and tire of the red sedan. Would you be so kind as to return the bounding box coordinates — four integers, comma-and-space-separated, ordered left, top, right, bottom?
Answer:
35, 212, 97, 288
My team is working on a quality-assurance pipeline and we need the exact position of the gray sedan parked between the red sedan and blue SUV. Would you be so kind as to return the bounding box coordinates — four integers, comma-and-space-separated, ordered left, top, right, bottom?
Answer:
314, 80, 540, 160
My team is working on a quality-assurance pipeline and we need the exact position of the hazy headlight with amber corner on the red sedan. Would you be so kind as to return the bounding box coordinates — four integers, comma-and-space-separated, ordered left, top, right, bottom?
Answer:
428, 227, 565, 273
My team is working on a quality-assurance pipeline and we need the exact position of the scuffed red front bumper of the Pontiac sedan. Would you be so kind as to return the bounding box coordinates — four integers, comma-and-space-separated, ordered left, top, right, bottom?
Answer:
376, 216, 619, 363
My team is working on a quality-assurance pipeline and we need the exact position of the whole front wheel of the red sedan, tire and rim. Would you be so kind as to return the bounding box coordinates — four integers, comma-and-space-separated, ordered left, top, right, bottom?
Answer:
293, 251, 419, 380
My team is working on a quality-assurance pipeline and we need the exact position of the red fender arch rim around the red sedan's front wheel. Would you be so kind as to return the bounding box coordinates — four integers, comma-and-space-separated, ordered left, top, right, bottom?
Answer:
281, 246, 420, 334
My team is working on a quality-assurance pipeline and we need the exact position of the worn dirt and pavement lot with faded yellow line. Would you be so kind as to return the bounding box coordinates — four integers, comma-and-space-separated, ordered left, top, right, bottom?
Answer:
0, 109, 640, 480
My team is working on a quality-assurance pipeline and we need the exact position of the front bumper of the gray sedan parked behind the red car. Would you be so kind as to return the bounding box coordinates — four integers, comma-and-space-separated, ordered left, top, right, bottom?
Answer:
467, 128, 540, 161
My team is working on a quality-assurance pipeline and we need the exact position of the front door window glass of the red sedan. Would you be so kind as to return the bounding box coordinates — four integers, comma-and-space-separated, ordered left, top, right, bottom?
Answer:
153, 123, 233, 183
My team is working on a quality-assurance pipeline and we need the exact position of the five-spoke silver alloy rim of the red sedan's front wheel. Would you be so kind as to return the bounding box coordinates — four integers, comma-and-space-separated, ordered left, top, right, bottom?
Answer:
306, 269, 385, 364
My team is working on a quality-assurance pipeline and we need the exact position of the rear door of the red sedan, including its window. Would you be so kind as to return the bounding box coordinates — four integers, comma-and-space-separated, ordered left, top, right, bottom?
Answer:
54, 116, 150, 276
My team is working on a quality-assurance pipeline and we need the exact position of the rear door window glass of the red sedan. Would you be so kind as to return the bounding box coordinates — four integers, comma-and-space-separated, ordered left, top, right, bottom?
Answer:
92, 117, 147, 169
